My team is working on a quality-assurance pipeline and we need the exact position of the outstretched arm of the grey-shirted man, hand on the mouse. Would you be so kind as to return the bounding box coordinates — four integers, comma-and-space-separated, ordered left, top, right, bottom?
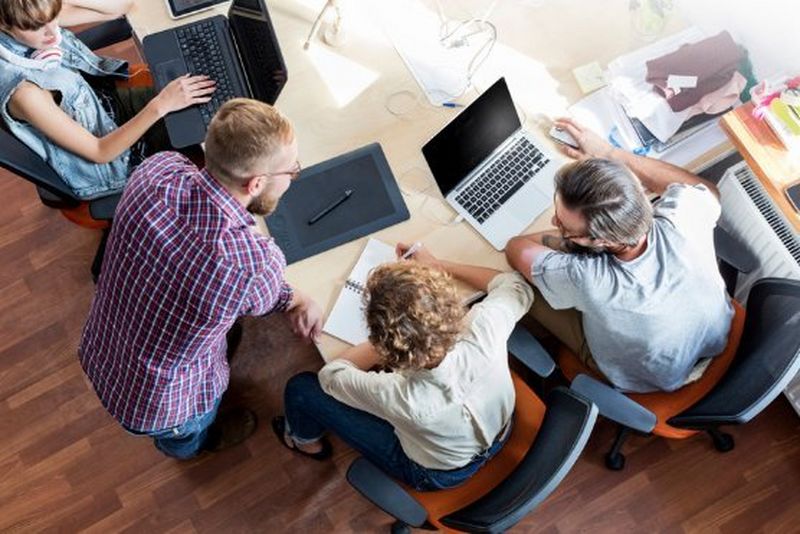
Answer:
556, 118, 719, 198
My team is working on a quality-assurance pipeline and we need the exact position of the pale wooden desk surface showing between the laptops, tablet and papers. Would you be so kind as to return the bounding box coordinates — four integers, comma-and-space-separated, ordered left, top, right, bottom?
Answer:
129, 0, 684, 357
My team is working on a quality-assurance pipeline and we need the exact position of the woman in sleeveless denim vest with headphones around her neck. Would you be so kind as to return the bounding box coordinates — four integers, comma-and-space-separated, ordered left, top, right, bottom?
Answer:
0, 0, 214, 199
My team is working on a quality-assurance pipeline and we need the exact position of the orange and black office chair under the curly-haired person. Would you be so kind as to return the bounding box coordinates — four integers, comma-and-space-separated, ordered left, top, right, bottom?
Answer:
347, 326, 597, 533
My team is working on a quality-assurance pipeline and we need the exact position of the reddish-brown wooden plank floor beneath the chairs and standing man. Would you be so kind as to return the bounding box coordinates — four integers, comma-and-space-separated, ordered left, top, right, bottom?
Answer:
0, 39, 800, 533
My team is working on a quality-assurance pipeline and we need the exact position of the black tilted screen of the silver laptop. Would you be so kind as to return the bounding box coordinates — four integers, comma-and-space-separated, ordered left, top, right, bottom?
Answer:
422, 78, 521, 196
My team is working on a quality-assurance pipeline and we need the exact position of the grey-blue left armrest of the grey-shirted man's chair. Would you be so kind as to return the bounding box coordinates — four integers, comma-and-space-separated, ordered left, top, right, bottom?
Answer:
570, 375, 656, 433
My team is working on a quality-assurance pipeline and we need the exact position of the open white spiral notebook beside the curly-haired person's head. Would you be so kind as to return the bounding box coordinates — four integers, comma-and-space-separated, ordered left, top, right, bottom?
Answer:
322, 238, 397, 345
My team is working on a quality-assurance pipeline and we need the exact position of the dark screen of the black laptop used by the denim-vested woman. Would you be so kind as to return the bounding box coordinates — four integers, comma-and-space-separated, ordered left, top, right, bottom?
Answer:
228, 0, 288, 104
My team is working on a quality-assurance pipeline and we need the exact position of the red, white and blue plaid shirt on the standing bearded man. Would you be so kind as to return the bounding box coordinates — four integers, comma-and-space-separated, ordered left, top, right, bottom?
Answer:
79, 152, 292, 432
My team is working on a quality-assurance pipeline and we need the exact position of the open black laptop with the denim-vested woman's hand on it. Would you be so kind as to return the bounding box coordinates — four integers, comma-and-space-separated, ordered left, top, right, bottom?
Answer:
142, 0, 287, 148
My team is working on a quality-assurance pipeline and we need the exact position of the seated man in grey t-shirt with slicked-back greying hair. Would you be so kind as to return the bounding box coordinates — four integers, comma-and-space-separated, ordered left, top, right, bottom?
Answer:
506, 119, 733, 392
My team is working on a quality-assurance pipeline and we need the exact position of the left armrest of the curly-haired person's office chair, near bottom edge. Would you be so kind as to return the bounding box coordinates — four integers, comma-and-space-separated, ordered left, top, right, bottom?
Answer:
347, 457, 428, 527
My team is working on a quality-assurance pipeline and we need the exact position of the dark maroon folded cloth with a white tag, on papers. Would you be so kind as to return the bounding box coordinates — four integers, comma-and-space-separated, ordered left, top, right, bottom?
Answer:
645, 31, 742, 111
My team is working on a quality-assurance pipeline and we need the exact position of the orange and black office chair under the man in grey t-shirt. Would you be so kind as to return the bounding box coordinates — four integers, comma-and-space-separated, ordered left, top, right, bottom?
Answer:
559, 278, 800, 470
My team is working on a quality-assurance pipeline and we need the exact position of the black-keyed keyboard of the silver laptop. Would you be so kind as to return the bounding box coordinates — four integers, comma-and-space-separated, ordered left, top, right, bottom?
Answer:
456, 137, 550, 223
